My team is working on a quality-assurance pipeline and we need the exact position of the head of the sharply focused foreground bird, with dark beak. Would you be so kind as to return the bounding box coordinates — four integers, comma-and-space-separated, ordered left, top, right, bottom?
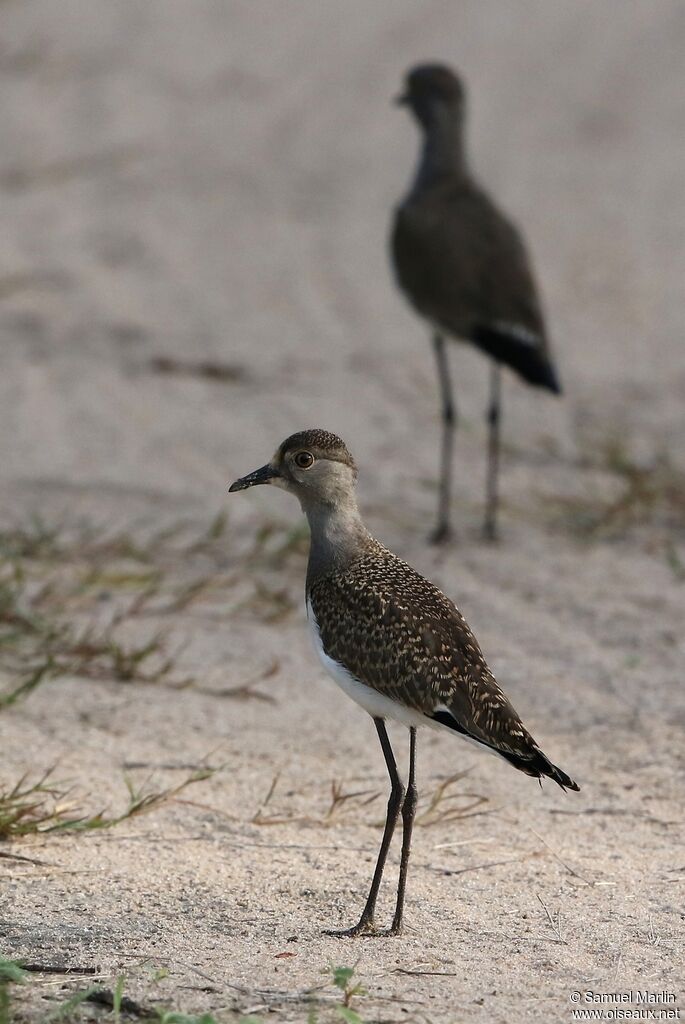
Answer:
229, 430, 356, 511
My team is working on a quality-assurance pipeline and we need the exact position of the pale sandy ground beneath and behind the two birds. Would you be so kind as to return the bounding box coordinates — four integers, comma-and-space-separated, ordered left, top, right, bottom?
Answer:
0, 0, 685, 1024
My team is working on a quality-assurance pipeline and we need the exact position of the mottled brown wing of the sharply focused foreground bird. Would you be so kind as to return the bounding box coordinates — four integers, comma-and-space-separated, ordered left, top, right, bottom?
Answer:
309, 552, 533, 754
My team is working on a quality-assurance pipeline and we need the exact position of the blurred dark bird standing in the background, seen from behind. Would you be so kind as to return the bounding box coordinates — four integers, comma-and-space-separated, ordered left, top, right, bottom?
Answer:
390, 63, 561, 543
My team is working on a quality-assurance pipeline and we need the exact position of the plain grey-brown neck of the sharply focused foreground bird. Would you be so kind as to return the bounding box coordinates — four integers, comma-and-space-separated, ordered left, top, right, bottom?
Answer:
303, 496, 373, 588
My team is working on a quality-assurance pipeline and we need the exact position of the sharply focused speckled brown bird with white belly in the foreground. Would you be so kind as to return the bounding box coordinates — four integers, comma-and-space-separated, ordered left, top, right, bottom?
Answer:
229, 429, 580, 937
